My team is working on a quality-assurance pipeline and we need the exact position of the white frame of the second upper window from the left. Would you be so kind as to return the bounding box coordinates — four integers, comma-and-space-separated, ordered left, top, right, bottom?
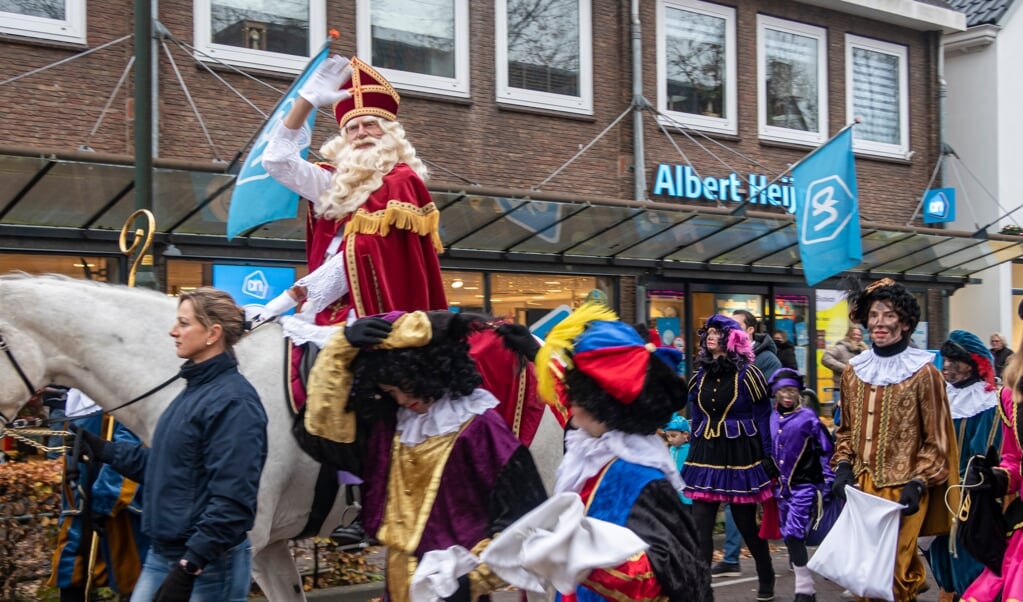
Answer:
192, 0, 326, 74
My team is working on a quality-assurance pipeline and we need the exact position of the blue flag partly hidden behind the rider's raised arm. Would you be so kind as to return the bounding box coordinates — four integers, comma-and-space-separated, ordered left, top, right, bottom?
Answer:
227, 44, 330, 241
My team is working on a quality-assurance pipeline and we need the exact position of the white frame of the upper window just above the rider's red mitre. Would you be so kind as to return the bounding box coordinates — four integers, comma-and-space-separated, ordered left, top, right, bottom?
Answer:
355, 0, 470, 98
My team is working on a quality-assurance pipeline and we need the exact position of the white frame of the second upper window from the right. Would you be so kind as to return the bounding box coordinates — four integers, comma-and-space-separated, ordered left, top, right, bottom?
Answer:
757, 14, 829, 145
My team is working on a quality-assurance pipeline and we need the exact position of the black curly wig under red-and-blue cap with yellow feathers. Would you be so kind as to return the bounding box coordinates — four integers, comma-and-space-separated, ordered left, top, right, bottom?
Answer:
565, 357, 686, 435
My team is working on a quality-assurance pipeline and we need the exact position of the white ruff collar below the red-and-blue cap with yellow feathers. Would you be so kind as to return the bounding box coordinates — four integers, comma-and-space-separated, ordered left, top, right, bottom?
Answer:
554, 429, 682, 493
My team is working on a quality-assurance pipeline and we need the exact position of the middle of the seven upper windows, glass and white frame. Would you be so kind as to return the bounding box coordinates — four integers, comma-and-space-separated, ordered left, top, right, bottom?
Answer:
494, 0, 593, 115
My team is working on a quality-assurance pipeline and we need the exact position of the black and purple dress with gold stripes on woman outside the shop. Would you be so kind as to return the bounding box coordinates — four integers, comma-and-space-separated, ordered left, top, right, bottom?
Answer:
682, 362, 772, 504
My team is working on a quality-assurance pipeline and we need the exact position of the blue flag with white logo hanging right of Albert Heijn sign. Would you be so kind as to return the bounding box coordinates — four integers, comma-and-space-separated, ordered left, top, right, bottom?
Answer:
792, 128, 863, 287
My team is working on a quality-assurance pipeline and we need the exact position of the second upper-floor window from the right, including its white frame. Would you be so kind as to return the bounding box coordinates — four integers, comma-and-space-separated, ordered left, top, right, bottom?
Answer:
757, 15, 828, 144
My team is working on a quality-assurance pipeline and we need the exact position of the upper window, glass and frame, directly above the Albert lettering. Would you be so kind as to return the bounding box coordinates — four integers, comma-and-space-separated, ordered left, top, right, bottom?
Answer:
657, 0, 738, 134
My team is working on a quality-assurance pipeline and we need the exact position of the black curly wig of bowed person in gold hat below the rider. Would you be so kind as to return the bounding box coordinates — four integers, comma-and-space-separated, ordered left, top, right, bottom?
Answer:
348, 311, 483, 419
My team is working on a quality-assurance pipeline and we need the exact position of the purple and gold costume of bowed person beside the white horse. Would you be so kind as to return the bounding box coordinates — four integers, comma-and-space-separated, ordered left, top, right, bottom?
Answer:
362, 410, 546, 600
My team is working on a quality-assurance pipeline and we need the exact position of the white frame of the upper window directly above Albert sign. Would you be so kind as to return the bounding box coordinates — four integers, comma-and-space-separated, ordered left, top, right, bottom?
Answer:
657, 0, 739, 135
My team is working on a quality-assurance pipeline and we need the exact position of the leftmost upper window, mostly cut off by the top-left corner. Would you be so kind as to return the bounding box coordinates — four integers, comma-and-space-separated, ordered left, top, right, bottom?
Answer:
0, 0, 86, 44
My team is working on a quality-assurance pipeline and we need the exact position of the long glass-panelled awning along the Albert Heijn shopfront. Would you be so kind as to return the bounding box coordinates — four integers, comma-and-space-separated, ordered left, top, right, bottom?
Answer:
0, 148, 1023, 287
